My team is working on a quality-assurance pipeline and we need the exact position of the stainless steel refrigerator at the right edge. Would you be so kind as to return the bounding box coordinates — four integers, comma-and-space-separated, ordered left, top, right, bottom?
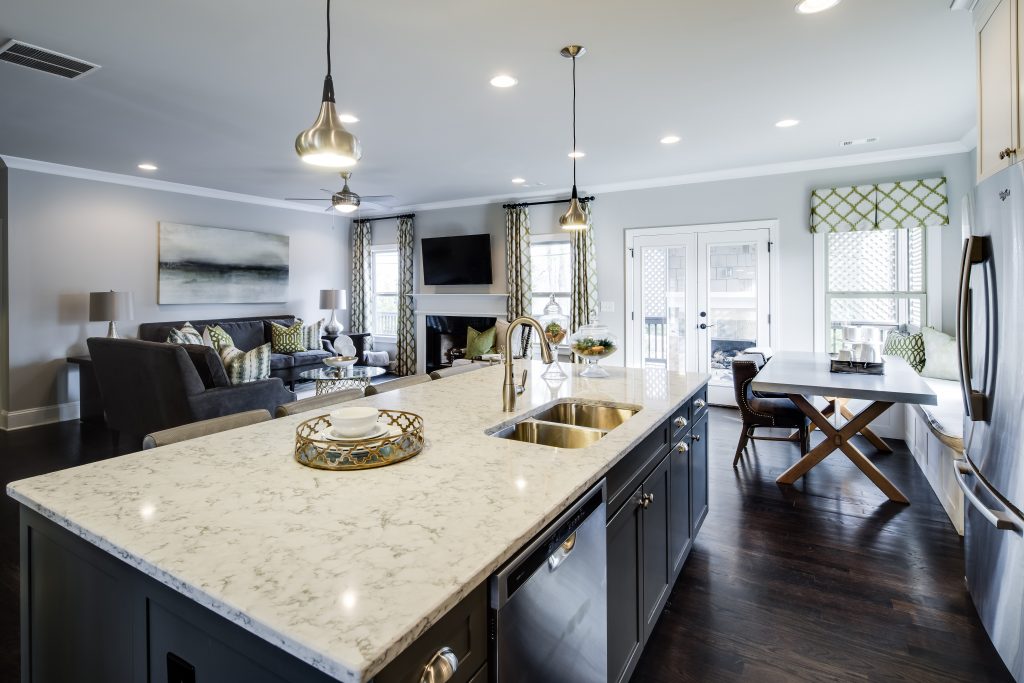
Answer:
954, 164, 1024, 682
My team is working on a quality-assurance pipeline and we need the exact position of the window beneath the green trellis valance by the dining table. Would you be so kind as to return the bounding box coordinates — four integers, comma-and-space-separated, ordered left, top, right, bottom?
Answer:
825, 227, 928, 352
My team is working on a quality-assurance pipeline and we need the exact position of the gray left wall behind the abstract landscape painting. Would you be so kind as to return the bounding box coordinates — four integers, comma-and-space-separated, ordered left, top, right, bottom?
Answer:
5, 170, 350, 412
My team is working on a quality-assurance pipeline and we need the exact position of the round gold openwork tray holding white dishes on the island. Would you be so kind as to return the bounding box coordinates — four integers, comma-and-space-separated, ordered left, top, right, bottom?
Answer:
295, 411, 423, 470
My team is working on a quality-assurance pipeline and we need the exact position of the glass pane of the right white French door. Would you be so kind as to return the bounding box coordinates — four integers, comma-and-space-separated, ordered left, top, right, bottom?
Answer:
712, 242, 759, 387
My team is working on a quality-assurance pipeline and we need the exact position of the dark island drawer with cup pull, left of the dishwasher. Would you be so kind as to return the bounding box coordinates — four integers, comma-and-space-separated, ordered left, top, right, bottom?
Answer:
374, 584, 487, 683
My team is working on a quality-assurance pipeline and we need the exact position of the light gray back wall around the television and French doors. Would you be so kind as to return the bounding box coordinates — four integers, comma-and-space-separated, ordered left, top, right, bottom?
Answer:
374, 154, 974, 361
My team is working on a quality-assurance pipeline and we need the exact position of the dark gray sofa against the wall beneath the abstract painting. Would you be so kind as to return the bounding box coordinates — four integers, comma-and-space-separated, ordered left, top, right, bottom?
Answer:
138, 315, 331, 389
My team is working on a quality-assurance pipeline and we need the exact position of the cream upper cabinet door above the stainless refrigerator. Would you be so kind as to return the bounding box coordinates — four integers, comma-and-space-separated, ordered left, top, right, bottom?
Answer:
978, 0, 1018, 180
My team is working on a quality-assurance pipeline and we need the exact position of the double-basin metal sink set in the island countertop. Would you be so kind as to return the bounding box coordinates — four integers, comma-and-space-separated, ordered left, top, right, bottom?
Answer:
490, 398, 640, 449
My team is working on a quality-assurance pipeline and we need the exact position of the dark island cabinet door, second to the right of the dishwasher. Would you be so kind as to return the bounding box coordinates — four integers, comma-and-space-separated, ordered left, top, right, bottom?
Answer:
642, 457, 672, 642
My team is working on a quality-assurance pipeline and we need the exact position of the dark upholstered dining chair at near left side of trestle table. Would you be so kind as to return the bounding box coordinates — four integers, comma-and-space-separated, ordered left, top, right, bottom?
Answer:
732, 356, 811, 467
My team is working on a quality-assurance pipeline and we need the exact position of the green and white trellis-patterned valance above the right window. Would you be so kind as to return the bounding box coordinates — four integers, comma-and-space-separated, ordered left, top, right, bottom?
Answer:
811, 178, 949, 232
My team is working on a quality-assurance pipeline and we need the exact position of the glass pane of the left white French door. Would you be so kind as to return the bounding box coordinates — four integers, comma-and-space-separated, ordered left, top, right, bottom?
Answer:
640, 247, 686, 372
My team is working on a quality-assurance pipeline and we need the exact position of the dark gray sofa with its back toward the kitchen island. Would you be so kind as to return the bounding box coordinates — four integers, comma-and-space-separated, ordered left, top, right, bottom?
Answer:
86, 337, 295, 448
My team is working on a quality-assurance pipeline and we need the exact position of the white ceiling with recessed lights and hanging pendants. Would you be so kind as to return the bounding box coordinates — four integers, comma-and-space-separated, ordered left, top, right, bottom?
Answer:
0, 0, 975, 206
